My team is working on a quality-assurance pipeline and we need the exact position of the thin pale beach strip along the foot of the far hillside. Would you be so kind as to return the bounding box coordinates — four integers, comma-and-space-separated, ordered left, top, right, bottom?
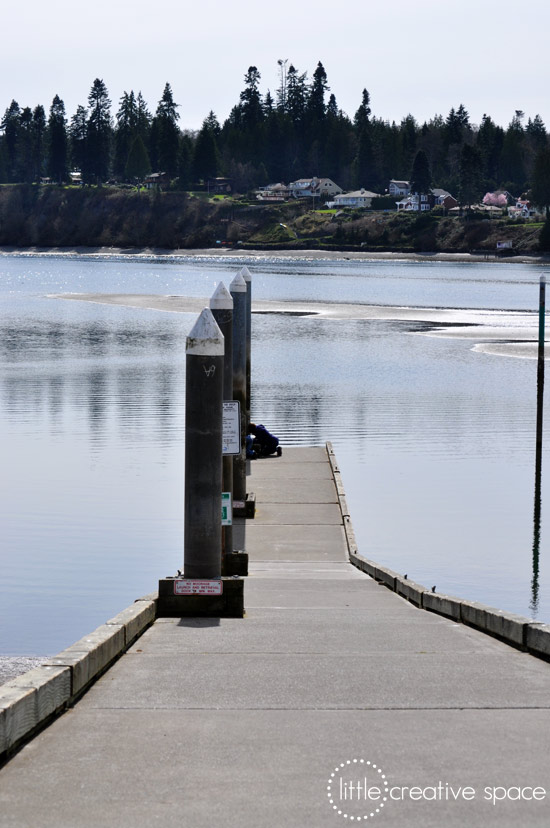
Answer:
0, 246, 550, 265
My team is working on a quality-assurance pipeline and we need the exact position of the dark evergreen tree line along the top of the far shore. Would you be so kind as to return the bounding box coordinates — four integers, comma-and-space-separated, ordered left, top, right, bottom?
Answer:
0, 61, 550, 205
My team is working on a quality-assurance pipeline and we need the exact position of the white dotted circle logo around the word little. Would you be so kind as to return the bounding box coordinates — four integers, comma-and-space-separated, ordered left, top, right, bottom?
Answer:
327, 759, 389, 822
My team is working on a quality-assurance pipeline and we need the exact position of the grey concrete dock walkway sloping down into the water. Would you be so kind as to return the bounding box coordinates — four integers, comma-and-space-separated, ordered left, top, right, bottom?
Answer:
0, 448, 550, 828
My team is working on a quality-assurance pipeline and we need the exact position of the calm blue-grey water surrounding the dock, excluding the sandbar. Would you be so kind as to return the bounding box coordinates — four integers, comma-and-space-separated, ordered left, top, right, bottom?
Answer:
0, 255, 550, 654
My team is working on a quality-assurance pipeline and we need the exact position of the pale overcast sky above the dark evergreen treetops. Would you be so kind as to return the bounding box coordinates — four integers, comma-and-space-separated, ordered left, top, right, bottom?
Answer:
0, 0, 550, 130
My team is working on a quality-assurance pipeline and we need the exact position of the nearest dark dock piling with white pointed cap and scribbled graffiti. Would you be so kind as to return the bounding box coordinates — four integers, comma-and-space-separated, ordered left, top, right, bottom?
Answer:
183, 308, 224, 579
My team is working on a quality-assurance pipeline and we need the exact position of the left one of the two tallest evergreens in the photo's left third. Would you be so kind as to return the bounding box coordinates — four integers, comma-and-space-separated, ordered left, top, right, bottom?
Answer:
83, 78, 111, 184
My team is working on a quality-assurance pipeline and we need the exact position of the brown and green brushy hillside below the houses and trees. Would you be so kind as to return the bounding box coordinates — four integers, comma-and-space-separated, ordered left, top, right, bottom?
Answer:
0, 185, 543, 254
